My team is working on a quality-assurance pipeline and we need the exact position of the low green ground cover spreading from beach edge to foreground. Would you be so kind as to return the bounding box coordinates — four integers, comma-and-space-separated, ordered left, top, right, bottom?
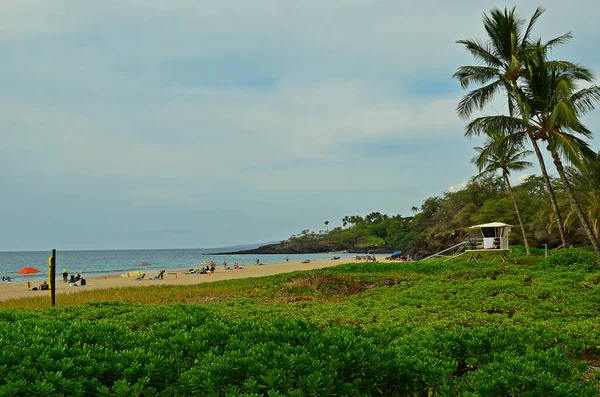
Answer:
0, 247, 600, 396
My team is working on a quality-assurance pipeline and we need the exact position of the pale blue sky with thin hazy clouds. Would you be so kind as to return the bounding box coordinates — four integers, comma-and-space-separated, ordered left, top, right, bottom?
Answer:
0, 0, 600, 251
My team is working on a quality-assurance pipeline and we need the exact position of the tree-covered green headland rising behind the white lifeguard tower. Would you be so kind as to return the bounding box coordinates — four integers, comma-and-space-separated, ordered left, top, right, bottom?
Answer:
243, 166, 600, 258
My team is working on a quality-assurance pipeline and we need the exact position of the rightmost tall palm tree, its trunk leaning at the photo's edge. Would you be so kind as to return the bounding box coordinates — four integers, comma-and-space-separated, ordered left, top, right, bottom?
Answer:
467, 43, 600, 256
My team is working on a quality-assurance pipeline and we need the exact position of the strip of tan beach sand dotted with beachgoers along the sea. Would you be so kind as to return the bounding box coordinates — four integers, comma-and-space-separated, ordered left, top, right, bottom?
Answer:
0, 258, 376, 301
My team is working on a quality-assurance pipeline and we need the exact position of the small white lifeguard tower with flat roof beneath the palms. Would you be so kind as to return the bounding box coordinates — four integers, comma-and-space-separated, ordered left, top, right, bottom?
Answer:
465, 222, 513, 263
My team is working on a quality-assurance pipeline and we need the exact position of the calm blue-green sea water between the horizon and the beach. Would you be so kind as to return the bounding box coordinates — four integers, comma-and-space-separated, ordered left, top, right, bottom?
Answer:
0, 249, 354, 287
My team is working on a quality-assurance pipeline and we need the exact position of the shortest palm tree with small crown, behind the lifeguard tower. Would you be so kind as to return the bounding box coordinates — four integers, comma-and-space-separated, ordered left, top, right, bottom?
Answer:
471, 131, 533, 256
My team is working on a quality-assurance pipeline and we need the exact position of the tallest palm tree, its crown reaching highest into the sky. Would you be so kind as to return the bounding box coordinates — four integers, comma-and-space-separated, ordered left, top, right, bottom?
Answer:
453, 7, 572, 244
